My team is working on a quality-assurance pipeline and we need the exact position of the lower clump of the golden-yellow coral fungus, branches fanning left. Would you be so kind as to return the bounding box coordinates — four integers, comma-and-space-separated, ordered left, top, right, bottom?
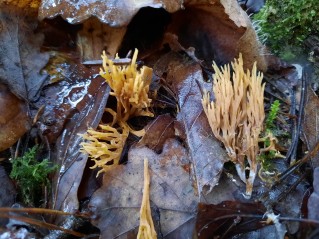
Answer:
81, 124, 129, 176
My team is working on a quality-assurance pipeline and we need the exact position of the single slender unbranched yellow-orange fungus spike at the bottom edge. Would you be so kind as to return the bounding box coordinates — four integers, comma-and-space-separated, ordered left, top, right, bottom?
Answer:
137, 159, 157, 239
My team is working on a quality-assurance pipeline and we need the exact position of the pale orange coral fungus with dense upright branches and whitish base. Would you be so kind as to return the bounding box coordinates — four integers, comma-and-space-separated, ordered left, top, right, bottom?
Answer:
202, 54, 265, 197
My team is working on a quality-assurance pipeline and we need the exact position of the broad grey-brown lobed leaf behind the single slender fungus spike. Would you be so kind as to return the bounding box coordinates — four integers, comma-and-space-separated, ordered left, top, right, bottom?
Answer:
89, 139, 197, 238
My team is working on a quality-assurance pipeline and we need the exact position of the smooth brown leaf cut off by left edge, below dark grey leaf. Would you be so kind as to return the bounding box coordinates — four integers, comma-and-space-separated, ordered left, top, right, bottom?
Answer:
0, 84, 31, 151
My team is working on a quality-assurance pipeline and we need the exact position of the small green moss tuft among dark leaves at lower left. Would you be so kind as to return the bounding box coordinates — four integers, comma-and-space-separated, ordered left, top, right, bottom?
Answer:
10, 146, 57, 205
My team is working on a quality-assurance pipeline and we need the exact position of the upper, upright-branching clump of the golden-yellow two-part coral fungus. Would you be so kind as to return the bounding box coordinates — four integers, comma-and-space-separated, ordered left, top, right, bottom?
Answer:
100, 49, 153, 122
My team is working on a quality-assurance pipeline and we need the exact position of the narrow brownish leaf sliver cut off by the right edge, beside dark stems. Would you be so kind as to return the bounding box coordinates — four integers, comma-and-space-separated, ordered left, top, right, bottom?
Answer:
302, 88, 319, 168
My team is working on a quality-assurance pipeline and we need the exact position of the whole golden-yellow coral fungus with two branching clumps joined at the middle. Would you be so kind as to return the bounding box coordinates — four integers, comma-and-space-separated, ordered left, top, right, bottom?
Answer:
81, 50, 153, 174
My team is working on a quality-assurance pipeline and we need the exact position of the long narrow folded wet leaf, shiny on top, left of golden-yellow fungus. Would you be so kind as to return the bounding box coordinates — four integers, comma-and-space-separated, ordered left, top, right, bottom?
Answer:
48, 75, 109, 217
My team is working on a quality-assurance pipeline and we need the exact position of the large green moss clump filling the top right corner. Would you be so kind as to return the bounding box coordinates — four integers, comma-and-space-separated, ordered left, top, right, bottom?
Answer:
254, 0, 319, 54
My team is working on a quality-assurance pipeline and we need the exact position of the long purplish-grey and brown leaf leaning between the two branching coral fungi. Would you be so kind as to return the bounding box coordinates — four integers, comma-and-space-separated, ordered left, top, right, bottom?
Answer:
154, 53, 229, 195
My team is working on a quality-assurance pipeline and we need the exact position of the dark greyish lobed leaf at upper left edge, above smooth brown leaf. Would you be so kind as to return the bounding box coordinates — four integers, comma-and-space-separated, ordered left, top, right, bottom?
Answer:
0, 4, 49, 101
